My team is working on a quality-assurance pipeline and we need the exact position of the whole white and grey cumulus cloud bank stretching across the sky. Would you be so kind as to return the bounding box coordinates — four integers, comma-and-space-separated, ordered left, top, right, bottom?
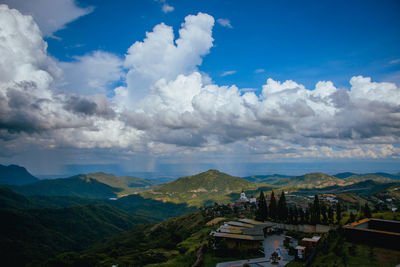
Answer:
0, 5, 400, 162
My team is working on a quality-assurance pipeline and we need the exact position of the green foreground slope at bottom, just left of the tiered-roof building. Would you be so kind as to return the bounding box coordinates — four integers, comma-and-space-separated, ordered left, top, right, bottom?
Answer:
44, 212, 209, 266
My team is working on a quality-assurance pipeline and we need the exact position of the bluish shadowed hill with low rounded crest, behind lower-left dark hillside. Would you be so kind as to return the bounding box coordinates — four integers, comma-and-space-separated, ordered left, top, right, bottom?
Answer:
11, 175, 122, 198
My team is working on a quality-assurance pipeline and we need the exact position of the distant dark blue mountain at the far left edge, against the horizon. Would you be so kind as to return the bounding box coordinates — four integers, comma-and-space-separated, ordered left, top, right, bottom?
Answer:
0, 164, 39, 185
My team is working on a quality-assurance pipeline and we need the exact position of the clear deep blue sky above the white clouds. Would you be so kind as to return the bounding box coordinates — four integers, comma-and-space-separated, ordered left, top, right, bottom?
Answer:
46, 0, 400, 89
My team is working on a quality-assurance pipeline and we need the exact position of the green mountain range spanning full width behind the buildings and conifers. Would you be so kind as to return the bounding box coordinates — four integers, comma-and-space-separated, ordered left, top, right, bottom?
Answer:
0, 165, 400, 266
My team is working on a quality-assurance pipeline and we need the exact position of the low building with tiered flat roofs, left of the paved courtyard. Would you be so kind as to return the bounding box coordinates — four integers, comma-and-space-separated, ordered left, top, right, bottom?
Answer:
210, 218, 275, 249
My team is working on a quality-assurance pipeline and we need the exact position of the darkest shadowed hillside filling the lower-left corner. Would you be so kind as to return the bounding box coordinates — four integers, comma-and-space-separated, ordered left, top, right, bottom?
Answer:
0, 187, 148, 266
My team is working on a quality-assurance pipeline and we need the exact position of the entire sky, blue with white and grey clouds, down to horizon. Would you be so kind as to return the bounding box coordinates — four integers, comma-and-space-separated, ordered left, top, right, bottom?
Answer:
0, 0, 400, 179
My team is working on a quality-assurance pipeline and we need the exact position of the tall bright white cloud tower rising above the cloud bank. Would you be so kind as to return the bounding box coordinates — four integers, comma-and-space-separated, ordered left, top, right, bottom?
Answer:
115, 13, 214, 108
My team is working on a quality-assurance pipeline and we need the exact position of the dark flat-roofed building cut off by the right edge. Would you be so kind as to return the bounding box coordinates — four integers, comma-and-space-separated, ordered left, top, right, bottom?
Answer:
343, 218, 400, 250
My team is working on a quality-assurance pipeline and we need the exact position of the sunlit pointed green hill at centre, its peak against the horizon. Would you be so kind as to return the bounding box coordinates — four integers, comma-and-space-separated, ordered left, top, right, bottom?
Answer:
142, 170, 265, 207
